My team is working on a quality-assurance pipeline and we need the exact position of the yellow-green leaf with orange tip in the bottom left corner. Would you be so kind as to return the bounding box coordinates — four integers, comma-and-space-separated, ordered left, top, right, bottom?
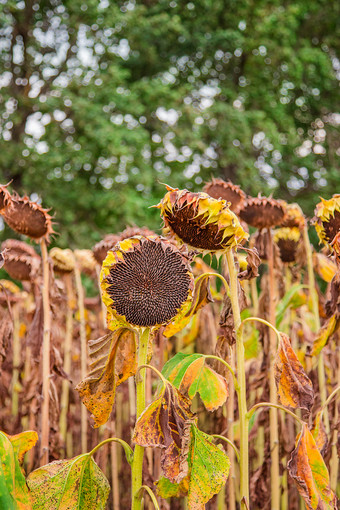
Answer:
0, 431, 38, 510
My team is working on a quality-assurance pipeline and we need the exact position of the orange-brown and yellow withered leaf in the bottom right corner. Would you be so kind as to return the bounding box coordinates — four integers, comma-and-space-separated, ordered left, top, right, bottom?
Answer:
287, 424, 337, 510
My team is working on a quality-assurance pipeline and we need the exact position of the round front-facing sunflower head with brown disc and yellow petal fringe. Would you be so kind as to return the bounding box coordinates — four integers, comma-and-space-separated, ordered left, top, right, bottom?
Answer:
100, 236, 194, 329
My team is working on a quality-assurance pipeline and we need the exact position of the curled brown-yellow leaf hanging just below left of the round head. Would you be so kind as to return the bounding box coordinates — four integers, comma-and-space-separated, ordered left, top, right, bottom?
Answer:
76, 328, 137, 427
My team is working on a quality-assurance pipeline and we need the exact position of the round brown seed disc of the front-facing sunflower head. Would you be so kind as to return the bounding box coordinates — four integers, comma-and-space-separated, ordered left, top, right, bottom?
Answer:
107, 239, 192, 327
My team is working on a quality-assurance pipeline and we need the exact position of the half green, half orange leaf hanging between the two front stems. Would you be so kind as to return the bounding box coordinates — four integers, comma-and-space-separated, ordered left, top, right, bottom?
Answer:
162, 352, 228, 411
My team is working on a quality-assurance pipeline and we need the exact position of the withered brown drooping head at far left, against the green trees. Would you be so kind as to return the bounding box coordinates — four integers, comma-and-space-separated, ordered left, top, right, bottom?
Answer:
2, 194, 54, 242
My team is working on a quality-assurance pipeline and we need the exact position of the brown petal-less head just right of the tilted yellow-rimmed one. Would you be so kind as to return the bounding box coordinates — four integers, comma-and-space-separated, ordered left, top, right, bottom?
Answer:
240, 195, 286, 230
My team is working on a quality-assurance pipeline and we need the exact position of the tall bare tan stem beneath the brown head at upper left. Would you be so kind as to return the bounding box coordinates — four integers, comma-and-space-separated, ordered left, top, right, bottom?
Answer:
40, 239, 51, 466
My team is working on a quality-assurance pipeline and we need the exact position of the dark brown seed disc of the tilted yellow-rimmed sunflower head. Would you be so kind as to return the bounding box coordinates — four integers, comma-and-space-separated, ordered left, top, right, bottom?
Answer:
164, 203, 231, 251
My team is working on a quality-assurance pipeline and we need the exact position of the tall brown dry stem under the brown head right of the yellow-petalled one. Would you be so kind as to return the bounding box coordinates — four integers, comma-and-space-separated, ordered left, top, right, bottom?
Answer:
267, 228, 280, 510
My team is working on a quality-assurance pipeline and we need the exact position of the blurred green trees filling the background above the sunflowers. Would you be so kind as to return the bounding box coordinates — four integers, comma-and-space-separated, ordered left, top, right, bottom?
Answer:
0, 0, 340, 246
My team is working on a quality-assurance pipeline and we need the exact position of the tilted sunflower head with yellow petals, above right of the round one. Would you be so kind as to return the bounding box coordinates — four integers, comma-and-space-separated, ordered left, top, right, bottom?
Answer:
156, 186, 248, 253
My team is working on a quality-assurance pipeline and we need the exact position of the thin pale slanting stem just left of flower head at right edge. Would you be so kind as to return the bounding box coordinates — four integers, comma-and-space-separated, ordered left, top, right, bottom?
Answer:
303, 224, 330, 434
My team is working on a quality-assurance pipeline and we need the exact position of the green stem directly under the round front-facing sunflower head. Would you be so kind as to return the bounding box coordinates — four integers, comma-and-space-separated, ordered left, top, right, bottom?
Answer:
131, 328, 150, 510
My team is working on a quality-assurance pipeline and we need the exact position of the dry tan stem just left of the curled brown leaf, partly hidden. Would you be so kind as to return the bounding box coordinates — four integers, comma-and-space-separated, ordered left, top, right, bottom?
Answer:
74, 262, 87, 453
